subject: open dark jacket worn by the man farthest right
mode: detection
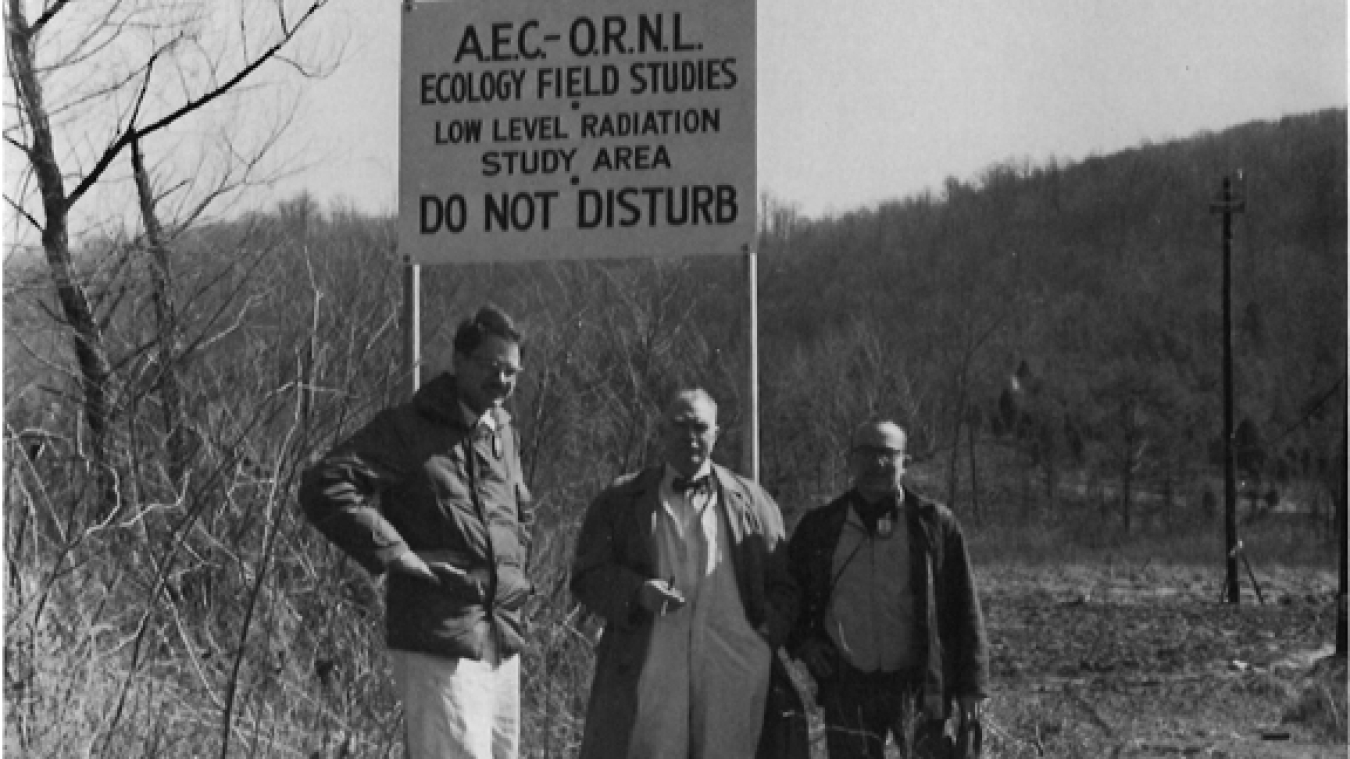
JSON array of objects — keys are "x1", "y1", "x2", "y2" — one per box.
[{"x1": 788, "y1": 489, "x2": 990, "y2": 718}]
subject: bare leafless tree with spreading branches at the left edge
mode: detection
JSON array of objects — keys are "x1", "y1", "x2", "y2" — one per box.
[{"x1": 5, "y1": 0, "x2": 328, "y2": 515}]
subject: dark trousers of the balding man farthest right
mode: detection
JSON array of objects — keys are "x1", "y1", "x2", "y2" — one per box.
[{"x1": 819, "y1": 664, "x2": 942, "y2": 759}]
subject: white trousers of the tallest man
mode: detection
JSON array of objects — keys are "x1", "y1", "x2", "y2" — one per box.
[{"x1": 389, "y1": 642, "x2": 520, "y2": 759}]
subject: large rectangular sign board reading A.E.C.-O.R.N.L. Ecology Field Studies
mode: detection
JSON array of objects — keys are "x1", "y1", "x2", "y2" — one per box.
[{"x1": 398, "y1": 0, "x2": 756, "y2": 263}]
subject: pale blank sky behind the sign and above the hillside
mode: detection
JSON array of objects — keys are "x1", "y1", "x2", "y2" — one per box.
[{"x1": 263, "y1": 0, "x2": 1347, "y2": 216}]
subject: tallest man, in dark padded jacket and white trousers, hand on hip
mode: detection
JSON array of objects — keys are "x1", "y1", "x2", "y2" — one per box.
[{"x1": 300, "y1": 307, "x2": 531, "y2": 759}]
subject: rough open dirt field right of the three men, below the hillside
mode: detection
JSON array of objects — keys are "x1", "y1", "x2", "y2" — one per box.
[{"x1": 793, "y1": 566, "x2": 1346, "y2": 759}]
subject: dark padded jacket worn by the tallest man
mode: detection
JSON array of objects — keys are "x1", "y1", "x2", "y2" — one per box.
[{"x1": 300, "y1": 374, "x2": 532, "y2": 659}]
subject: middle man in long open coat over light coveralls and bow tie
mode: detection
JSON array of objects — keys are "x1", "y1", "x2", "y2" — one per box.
[{"x1": 571, "y1": 390, "x2": 797, "y2": 759}]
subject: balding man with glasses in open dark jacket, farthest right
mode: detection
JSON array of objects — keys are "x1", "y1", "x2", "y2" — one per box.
[{"x1": 788, "y1": 421, "x2": 988, "y2": 759}]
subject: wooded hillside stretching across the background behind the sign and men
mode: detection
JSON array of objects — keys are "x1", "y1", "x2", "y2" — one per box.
[{"x1": 7, "y1": 109, "x2": 1347, "y2": 526}]
